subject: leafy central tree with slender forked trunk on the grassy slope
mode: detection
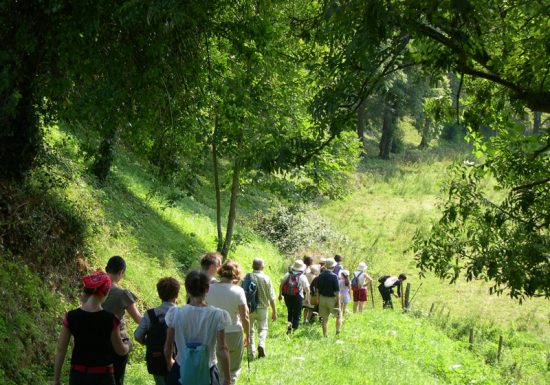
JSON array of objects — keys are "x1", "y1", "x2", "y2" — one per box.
[{"x1": 209, "y1": 2, "x2": 362, "y2": 257}]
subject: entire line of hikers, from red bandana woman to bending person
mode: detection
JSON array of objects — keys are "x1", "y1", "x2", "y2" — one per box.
[{"x1": 54, "y1": 253, "x2": 406, "y2": 385}]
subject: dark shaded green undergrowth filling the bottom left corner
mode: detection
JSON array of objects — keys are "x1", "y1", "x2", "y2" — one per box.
[{"x1": 0, "y1": 254, "x2": 67, "y2": 385}]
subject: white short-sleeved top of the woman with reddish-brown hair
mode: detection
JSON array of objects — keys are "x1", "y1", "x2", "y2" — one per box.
[{"x1": 206, "y1": 282, "x2": 246, "y2": 332}]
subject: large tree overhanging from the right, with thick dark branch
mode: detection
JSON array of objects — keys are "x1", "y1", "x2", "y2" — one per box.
[{"x1": 312, "y1": 0, "x2": 550, "y2": 298}]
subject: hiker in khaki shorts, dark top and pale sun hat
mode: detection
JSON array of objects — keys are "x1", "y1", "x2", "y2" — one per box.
[{"x1": 316, "y1": 258, "x2": 342, "y2": 337}]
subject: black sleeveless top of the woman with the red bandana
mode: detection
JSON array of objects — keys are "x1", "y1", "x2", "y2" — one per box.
[{"x1": 65, "y1": 308, "x2": 120, "y2": 366}]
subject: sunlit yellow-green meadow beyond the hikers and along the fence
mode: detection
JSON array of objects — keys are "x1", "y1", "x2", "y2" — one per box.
[{"x1": 318, "y1": 152, "x2": 550, "y2": 339}]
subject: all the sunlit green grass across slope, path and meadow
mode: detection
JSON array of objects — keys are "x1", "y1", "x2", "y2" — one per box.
[{"x1": 0, "y1": 124, "x2": 550, "y2": 385}]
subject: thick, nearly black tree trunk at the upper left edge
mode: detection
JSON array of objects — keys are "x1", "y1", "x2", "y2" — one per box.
[{"x1": 0, "y1": 1, "x2": 46, "y2": 182}]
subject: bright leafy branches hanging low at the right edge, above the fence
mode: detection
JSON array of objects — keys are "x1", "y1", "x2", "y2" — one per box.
[{"x1": 414, "y1": 121, "x2": 550, "y2": 300}]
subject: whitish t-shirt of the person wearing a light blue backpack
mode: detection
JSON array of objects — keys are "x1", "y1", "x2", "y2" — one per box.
[{"x1": 164, "y1": 305, "x2": 231, "y2": 367}]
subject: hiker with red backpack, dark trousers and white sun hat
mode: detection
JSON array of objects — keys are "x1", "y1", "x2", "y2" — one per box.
[{"x1": 279, "y1": 259, "x2": 310, "y2": 334}]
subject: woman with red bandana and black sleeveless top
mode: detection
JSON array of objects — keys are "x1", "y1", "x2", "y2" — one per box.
[{"x1": 53, "y1": 271, "x2": 132, "y2": 385}]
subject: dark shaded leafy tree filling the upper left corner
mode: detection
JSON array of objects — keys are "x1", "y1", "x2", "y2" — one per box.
[{"x1": 0, "y1": 1, "x2": 211, "y2": 181}]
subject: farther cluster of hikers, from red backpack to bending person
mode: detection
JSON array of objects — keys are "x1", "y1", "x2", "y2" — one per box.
[{"x1": 279, "y1": 254, "x2": 407, "y2": 337}]
